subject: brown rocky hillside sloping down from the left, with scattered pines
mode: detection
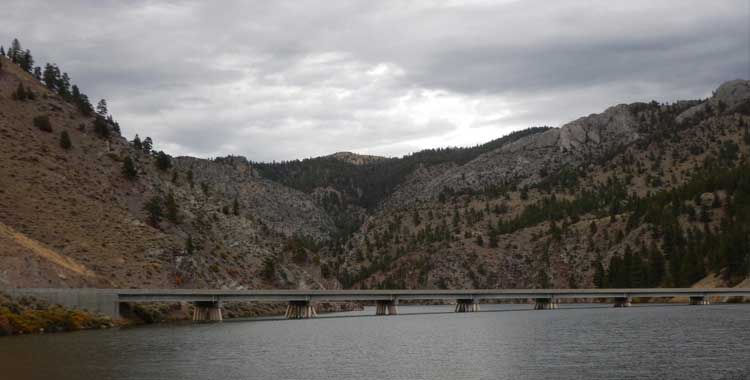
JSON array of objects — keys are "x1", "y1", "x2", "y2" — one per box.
[{"x1": 0, "y1": 53, "x2": 336, "y2": 288}]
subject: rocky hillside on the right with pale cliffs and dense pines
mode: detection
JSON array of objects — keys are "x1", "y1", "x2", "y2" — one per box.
[{"x1": 340, "y1": 81, "x2": 750, "y2": 288}]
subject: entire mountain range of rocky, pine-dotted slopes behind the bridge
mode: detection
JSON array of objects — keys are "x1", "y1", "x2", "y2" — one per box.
[{"x1": 0, "y1": 51, "x2": 750, "y2": 294}]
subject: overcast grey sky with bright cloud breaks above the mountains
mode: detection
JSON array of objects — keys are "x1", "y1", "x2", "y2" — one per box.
[{"x1": 0, "y1": 0, "x2": 750, "y2": 161}]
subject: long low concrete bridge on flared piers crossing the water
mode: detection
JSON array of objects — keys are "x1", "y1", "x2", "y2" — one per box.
[{"x1": 0, "y1": 288, "x2": 750, "y2": 321}]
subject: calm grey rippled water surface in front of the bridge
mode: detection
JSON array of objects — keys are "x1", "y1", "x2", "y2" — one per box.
[{"x1": 0, "y1": 305, "x2": 750, "y2": 380}]
